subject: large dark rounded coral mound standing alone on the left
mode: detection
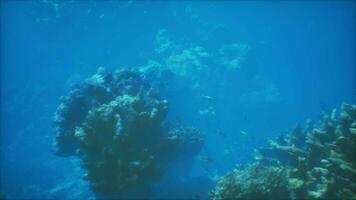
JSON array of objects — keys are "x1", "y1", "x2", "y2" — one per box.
[{"x1": 54, "y1": 68, "x2": 203, "y2": 197}]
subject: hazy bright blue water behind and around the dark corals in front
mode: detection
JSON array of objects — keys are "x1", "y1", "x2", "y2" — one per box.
[{"x1": 0, "y1": 0, "x2": 356, "y2": 199}]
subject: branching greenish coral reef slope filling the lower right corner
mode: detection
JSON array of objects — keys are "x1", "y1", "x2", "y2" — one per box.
[{"x1": 210, "y1": 104, "x2": 356, "y2": 199}]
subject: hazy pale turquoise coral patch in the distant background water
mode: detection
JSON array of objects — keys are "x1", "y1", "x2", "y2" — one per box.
[{"x1": 139, "y1": 29, "x2": 251, "y2": 84}]
